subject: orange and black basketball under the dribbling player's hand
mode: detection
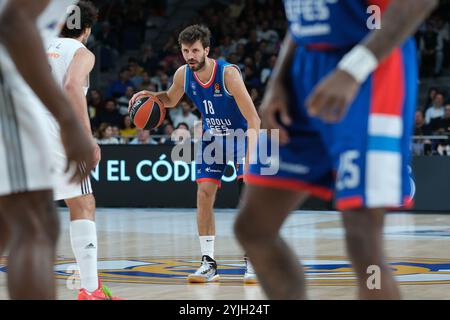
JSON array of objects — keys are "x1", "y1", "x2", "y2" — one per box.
[{"x1": 130, "y1": 96, "x2": 166, "y2": 130}]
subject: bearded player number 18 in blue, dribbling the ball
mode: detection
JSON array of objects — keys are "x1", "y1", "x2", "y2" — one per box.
[{"x1": 130, "y1": 25, "x2": 260, "y2": 283}]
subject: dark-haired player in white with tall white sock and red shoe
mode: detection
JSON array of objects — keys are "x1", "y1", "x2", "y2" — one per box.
[{"x1": 46, "y1": 1, "x2": 120, "y2": 300}]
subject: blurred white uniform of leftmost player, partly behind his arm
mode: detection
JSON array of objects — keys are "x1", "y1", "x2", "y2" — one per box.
[{"x1": 0, "y1": 0, "x2": 78, "y2": 196}]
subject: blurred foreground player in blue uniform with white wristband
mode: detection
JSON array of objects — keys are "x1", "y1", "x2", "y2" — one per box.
[{"x1": 235, "y1": 0, "x2": 437, "y2": 299}]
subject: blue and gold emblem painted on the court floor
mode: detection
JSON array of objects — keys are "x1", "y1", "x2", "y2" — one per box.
[{"x1": 39, "y1": 256, "x2": 450, "y2": 286}]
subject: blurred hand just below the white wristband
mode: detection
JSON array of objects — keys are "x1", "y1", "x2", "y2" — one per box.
[{"x1": 306, "y1": 69, "x2": 360, "y2": 122}]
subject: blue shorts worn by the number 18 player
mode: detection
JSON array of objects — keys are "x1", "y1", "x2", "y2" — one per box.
[{"x1": 195, "y1": 136, "x2": 246, "y2": 187}]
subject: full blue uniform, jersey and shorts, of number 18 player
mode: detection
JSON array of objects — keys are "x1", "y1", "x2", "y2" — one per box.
[{"x1": 184, "y1": 60, "x2": 247, "y2": 185}]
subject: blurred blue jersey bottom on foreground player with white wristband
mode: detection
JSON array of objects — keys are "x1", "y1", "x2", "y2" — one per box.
[{"x1": 284, "y1": 0, "x2": 390, "y2": 49}]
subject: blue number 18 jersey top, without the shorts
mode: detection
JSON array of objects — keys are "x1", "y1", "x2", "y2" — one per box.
[{"x1": 184, "y1": 60, "x2": 247, "y2": 136}]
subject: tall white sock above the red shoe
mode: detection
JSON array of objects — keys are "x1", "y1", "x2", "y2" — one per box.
[{"x1": 70, "y1": 220, "x2": 98, "y2": 292}]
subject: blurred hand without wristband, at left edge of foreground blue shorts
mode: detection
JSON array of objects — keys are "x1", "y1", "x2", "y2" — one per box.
[{"x1": 260, "y1": 83, "x2": 292, "y2": 144}]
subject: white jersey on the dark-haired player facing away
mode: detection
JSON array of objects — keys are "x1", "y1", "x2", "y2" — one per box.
[{"x1": 47, "y1": 38, "x2": 89, "y2": 95}]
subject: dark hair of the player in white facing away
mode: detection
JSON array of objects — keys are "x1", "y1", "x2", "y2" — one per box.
[{"x1": 61, "y1": 1, "x2": 98, "y2": 38}]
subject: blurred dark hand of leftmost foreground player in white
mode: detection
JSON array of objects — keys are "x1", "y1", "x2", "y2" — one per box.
[{"x1": 60, "y1": 121, "x2": 97, "y2": 183}]
